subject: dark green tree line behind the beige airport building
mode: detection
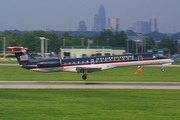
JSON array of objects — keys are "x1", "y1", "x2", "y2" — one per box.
[{"x1": 0, "y1": 30, "x2": 178, "y2": 54}]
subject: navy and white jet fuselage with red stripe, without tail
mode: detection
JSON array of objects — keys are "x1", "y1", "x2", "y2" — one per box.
[{"x1": 22, "y1": 53, "x2": 173, "y2": 72}]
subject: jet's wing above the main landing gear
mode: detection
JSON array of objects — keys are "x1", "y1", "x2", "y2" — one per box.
[{"x1": 76, "y1": 67, "x2": 102, "y2": 73}]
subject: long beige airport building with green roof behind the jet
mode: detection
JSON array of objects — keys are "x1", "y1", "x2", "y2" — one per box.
[{"x1": 60, "y1": 46, "x2": 125, "y2": 58}]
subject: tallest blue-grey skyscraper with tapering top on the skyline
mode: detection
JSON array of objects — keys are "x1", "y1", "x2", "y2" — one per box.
[{"x1": 93, "y1": 5, "x2": 106, "y2": 32}]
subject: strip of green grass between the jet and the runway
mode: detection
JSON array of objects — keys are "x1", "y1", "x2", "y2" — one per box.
[{"x1": 0, "y1": 66, "x2": 180, "y2": 82}]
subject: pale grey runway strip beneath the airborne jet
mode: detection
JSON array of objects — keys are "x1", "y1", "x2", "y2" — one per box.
[{"x1": 0, "y1": 81, "x2": 180, "y2": 89}]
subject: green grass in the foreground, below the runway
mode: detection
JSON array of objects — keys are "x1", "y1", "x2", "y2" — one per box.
[{"x1": 0, "y1": 89, "x2": 180, "y2": 120}]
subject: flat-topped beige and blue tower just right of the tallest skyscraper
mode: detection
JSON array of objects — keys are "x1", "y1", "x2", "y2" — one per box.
[{"x1": 108, "y1": 18, "x2": 119, "y2": 32}]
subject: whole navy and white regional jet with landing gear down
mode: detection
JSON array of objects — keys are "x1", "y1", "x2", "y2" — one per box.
[{"x1": 8, "y1": 46, "x2": 174, "y2": 80}]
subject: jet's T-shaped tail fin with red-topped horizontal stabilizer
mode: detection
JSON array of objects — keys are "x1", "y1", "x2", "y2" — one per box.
[{"x1": 7, "y1": 46, "x2": 37, "y2": 65}]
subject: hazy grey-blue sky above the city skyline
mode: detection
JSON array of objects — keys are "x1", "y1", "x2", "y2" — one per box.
[{"x1": 0, "y1": 0, "x2": 180, "y2": 33}]
